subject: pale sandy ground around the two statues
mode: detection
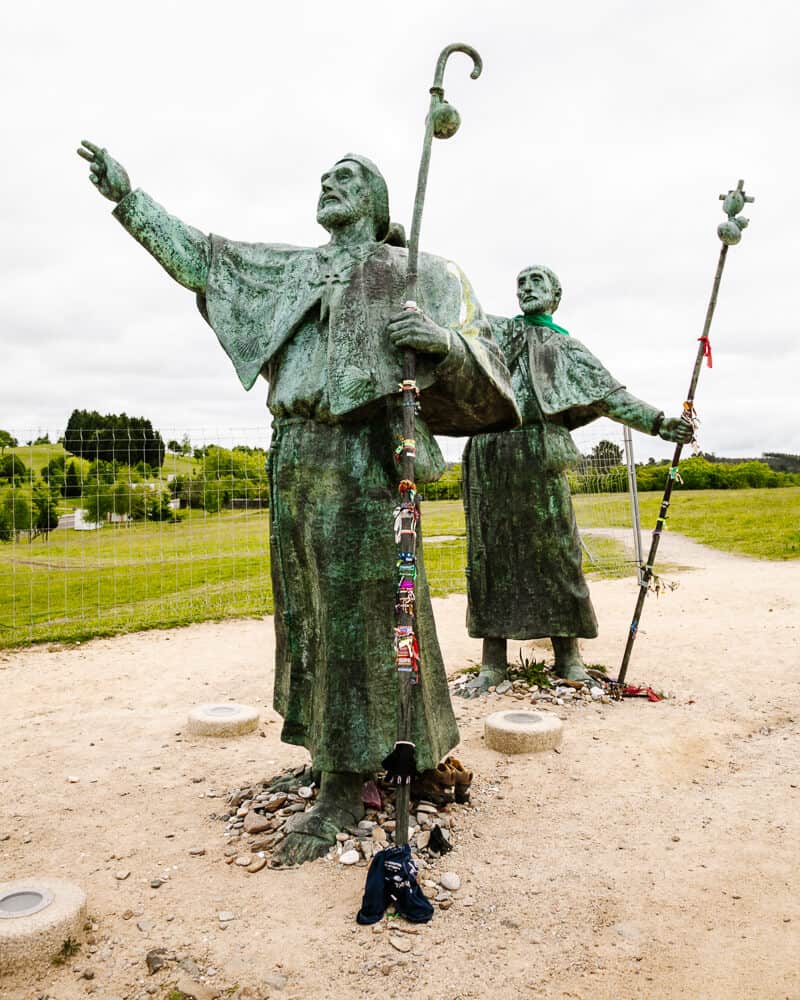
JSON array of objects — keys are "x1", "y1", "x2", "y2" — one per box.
[{"x1": 0, "y1": 535, "x2": 800, "y2": 1000}]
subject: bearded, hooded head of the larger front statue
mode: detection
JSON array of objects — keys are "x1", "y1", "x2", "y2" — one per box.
[{"x1": 317, "y1": 153, "x2": 389, "y2": 240}]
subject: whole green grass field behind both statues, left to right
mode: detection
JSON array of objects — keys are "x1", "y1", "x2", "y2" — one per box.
[{"x1": 0, "y1": 486, "x2": 800, "y2": 647}]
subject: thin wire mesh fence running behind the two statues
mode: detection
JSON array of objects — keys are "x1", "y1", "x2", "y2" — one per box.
[{"x1": 0, "y1": 421, "x2": 635, "y2": 647}]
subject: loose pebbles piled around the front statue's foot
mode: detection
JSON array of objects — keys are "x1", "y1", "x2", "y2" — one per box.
[{"x1": 212, "y1": 767, "x2": 462, "y2": 874}]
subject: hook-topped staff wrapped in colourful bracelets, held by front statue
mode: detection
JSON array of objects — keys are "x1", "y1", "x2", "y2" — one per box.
[{"x1": 384, "y1": 43, "x2": 483, "y2": 847}]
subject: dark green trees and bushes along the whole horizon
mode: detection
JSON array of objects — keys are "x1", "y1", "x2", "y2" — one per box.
[{"x1": 0, "y1": 410, "x2": 800, "y2": 541}]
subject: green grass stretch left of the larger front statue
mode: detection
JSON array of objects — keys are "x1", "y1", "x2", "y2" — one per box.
[{"x1": 0, "y1": 511, "x2": 272, "y2": 646}]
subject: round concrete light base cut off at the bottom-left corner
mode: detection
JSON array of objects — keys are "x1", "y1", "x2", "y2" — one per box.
[{"x1": 0, "y1": 878, "x2": 86, "y2": 973}]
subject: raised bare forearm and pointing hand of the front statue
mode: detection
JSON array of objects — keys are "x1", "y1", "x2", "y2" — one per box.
[{"x1": 78, "y1": 139, "x2": 211, "y2": 292}]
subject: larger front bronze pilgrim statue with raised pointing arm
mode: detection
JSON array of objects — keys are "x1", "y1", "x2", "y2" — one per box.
[{"x1": 78, "y1": 142, "x2": 518, "y2": 863}]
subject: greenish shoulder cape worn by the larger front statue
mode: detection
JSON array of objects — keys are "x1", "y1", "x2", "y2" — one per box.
[{"x1": 198, "y1": 236, "x2": 519, "y2": 434}]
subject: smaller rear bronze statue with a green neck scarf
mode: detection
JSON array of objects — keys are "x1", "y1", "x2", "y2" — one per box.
[{"x1": 463, "y1": 266, "x2": 692, "y2": 695}]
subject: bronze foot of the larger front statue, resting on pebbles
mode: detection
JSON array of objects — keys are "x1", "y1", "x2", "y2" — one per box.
[{"x1": 272, "y1": 773, "x2": 364, "y2": 867}]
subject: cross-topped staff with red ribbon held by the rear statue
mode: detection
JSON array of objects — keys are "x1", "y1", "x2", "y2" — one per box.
[{"x1": 617, "y1": 180, "x2": 755, "y2": 690}]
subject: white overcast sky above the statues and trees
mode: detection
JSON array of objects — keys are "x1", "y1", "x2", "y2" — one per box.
[{"x1": 0, "y1": 0, "x2": 800, "y2": 457}]
